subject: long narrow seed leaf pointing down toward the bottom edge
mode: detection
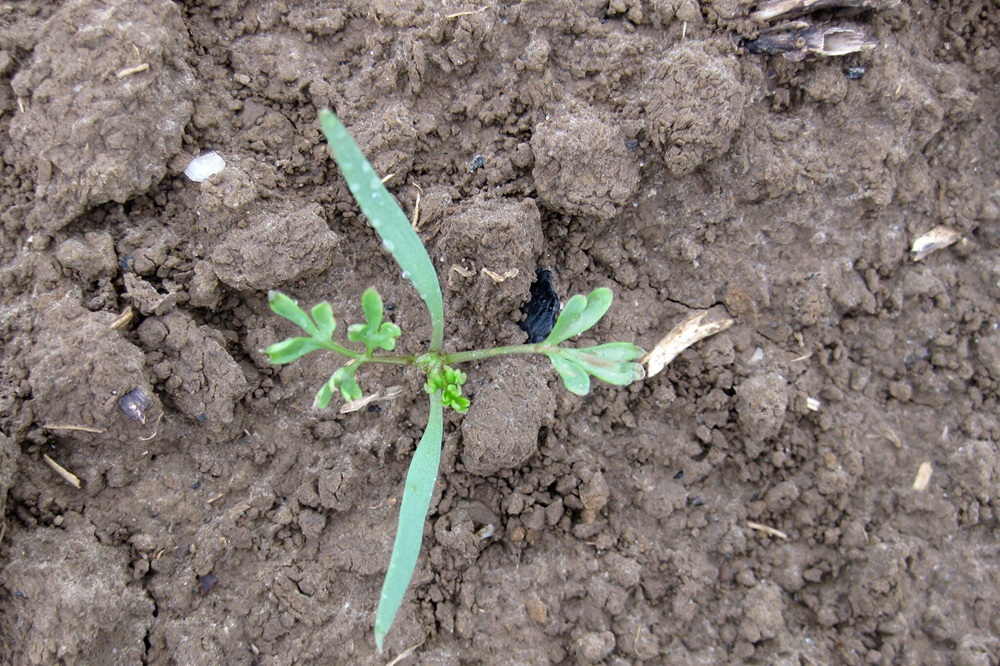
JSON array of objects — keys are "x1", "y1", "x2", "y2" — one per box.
[{"x1": 375, "y1": 393, "x2": 444, "y2": 652}]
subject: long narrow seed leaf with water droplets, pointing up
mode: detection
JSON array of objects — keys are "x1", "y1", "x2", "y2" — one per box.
[{"x1": 319, "y1": 109, "x2": 444, "y2": 351}]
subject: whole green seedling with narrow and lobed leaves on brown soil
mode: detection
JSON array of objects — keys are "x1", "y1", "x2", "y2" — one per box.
[{"x1": 264, "y1": 109, "x2": 645, "y2": 651}]
